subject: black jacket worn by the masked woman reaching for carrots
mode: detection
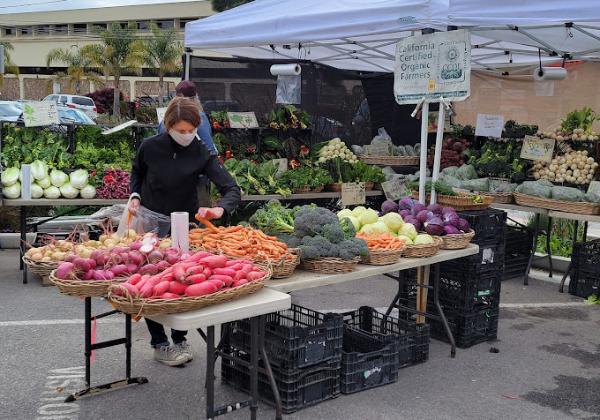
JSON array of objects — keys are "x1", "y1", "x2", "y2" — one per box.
[{"x1": 130, "y1": 133, "x2": 241, "y2": 220}]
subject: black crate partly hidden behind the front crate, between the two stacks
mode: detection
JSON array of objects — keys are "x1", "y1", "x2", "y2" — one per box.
[{"x1": 343, "y1": 306, "x2": 429, "y2": 368}]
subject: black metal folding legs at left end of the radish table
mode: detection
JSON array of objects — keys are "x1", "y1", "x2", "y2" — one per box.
[{"x1": 65, "y1": 297, "x2": 148, "y2": 402}]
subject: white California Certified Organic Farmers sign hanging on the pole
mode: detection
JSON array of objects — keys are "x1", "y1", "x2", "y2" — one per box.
[{"x1": 394, "y1": 30, "x2": 471, "y2": 105}]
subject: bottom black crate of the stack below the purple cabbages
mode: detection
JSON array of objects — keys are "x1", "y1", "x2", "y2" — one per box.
[{"x1": 427, "y1": 303, "x2": 500, "y2": 349}]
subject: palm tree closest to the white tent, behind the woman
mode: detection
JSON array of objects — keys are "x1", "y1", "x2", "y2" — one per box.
[{"x1": 142, "y1": 23, "x2": 183, "y2": 107}]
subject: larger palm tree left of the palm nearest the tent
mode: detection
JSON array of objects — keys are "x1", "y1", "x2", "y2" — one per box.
[{"x1": 81, "y1": 22, "x2": 144, "y2": 117}]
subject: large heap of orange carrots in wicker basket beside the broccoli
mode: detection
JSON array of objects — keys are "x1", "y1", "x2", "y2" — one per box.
[{"x1": 189, "y1": 219, "x2": 301, "y2": 279}]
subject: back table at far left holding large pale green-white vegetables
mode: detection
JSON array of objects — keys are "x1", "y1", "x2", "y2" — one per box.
[{"x1": 2, "y1": 198, "x2": 127, "y2": 284}]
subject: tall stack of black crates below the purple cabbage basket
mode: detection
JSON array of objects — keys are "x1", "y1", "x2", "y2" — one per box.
[{"x1": 399, "y1": 209, "x2": 506, "y2": 348}]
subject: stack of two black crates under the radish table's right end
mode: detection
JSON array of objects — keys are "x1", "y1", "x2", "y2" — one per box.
[{"x1": 221, "y1": 305, "x2": 344, "y2": 414}]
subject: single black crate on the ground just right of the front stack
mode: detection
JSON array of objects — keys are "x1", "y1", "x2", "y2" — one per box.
[{"x1": 340, "y1": 327, "x2": 399, "y2": 394}]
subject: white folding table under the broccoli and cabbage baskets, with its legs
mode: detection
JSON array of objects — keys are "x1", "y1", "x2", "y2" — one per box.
[{"x1": 265, "y1": 244, "x2": 479, "y2": 357}]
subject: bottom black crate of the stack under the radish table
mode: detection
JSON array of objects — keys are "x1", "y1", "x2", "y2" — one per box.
[{"x1": 221, "y1": 346, "x2": 341, "y2": 414}]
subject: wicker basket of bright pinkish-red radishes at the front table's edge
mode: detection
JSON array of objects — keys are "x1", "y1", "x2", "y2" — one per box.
[{"x1": 108, "y1": 251, "x2": 272, "y2": 316}]
